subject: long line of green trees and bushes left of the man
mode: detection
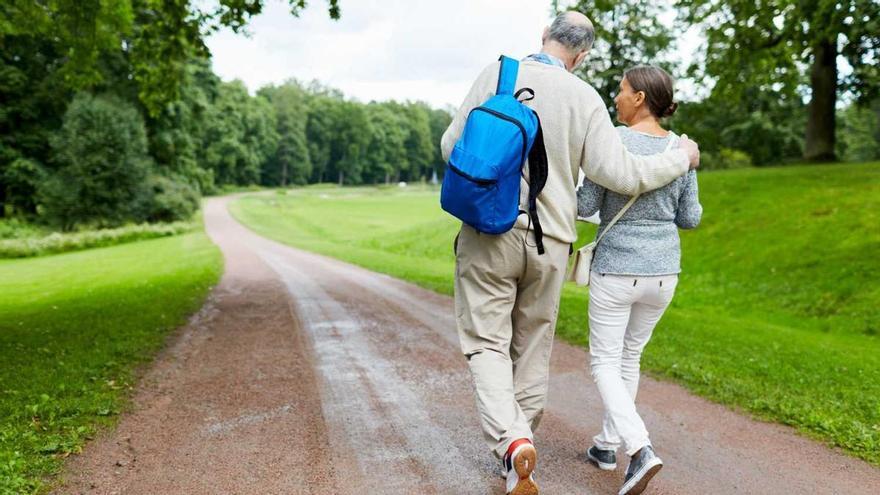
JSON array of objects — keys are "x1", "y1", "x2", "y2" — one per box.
[{"x1": 0, "y1": 54, "x2": 451, "y2": 230}]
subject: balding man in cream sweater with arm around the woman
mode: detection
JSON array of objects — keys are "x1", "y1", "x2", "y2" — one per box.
[{"x1": 441, "y1": 8, "x2": 699, "y2": 495}]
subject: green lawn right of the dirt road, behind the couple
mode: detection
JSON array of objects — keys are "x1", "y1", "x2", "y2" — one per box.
[{"x1": 231, "y1": 163, "x2": 880, "y2": 465}]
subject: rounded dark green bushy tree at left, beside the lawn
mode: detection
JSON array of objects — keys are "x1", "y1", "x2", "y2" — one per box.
[{"x1": 39, "y1": 93, "x2": 151, "y2": 230}]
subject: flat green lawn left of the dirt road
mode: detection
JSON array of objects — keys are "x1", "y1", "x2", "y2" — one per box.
[{"x1": 0, "y1": 232, "x2": 222, "y2": 494}]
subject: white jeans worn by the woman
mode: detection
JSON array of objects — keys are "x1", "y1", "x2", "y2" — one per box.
[{"x1": 589, "y1": 272, "x2": 678, "y2": 456}]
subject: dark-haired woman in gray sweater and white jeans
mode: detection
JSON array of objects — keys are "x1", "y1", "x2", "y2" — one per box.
[{"x1": 578, "y1": 66, "x2": 702, "y2": 495}]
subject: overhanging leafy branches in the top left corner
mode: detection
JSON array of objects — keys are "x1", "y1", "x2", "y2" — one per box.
[{"x1": 0, "y1": 0, "x2": 340, "y2": 116}]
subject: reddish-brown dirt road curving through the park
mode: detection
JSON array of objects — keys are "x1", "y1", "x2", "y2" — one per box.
[{"x1": 58, "y1": 198, "x2": 880, "y2": 495}]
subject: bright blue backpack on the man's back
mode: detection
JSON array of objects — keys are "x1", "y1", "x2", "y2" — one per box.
[{"x1": 440, "y1": 55, "x2": 547, "y2": 254}]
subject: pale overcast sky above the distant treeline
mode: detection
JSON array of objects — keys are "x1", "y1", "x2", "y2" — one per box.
[{"x1": 208, "y1": 0, "x2": 700, "y2": 107}]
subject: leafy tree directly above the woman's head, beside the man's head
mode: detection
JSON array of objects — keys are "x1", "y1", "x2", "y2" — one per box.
[{"x1": 554, "y1": 0, "x2": 674, "y2": 118}]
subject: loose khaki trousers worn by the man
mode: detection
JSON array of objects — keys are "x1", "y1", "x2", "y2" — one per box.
[{"x1": 455, "y1": 225, "x2": 569, "y2": 458}]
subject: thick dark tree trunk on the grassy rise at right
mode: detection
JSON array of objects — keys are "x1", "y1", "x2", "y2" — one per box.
[{"x1": 804, "y1": 40, "x2": 837, "y2": 162}]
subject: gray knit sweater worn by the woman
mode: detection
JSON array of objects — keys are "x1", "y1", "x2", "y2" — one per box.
[{"x1": 577, "y1": 127, "x2": 703, "y2": 275}]
